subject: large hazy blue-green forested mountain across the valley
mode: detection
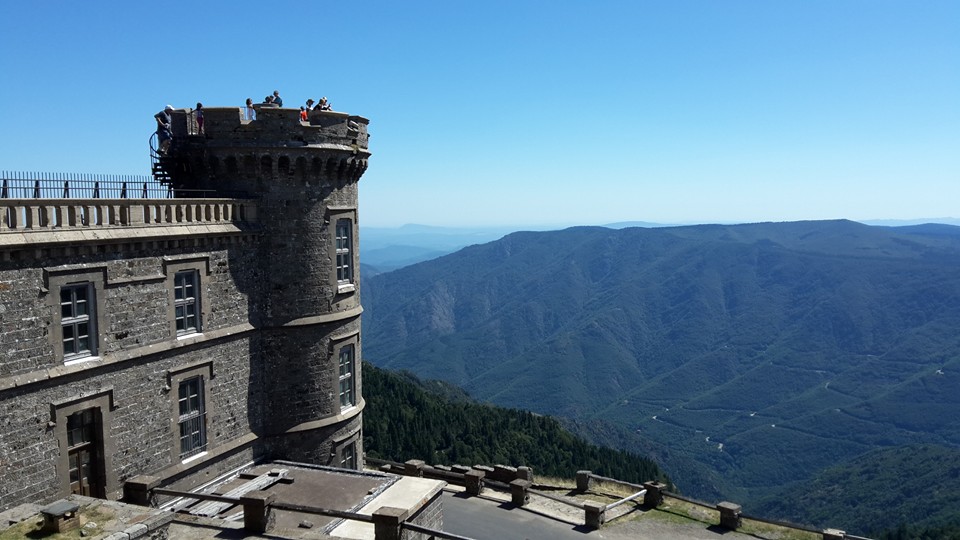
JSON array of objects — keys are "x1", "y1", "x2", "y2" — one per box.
[{"x1": 363, "y1": 221, "x2": 960, "y2": 520}]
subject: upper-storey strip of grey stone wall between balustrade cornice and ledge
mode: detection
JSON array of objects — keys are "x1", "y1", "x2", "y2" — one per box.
[{"x1": 0, "y1": 239, "x2": 261, "y2": 380}]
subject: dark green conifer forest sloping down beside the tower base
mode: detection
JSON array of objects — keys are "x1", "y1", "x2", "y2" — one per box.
[{"x1": 363, "y1": 364, "x2": 672, "y2": 486}]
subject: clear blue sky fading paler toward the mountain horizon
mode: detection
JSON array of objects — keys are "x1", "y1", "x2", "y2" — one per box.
[{"x1": 0, "y1": 0, "x2": 960, "y2": 226}]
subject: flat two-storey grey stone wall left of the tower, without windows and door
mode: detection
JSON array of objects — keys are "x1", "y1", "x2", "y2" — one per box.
[{"x1": 0, "y1": 236, "x2": 264, "y2": 508}]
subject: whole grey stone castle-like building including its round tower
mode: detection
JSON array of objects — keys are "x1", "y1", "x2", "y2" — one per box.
[{"x1": 0, "y1": 103, "x2": 370, "y2": 510}]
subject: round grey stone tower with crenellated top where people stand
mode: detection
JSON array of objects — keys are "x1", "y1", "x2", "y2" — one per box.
[{"x1": 159, "y1": 107, "x2": 370, "y2": 468}]
